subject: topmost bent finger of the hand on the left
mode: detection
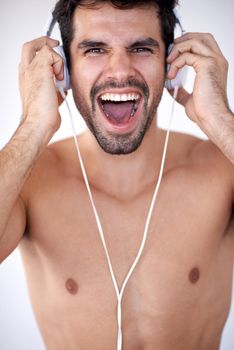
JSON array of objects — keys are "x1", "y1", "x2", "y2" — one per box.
[{"x1": 20, "y1": 36, "x2": 59, "y2": 69}]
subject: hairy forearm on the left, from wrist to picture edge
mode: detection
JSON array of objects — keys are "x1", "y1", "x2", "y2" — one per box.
[{"x1": 0, "y1": 122, "x2": 50, "y2": 238}]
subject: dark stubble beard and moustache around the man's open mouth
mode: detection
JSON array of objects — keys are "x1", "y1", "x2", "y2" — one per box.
[{"x1": 73, "y1": 81, "x2": 163, "y2": 155}]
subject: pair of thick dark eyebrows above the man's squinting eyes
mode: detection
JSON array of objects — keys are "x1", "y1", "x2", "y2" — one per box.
[{"x1": 78, "y1": 38, "x2": 160, "y2": 50}]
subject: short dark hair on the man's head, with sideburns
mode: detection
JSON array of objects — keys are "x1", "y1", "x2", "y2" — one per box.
[{"x1": 53, "y1": 0, "x2": 177, "y2": 70}]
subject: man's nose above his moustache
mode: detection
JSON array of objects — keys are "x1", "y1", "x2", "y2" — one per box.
[{"x1": 106, "y1": 50, "x2": 136, "y2": 82}]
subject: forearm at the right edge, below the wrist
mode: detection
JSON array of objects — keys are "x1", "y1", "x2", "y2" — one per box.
[{"x1": 202, "y1": 111, "x2": 234, "y2": 165}]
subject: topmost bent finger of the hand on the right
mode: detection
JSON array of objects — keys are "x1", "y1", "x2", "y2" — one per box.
[{"x1": 174, "y1": 33, "x2": 222, "y2": 55}]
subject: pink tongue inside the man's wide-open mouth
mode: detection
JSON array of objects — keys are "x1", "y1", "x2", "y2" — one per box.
[{"x1": 103, "y1": 102, "x2": 134, "y2": 124}]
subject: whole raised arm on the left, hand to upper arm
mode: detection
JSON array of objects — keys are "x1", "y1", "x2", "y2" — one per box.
[{"x1": 0, "y1": 37, "x2": 63, "y2": 262}]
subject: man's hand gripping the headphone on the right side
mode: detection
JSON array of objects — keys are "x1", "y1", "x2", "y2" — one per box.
[{"x1": 167, "y1": 33, "x2": 229, "y2": 124}]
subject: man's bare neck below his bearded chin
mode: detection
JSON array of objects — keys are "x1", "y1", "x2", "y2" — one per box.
[{"x1": 82, "y1": 120, "x2": 165, "y2": 198}]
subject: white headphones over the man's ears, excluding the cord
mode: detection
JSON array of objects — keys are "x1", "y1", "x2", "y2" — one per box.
[{"x1": 44, "y1": 9, "x2": 188, "y2": 91}]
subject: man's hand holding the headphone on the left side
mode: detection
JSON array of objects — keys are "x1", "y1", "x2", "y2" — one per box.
[{"x1": 19, "y1": 37, "x2": 63, "y2": 134}]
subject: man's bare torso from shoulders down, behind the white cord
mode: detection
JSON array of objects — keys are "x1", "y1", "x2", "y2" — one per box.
[{"x1": 18, "y1": 129, "x2": 234, "y2": 350}]
